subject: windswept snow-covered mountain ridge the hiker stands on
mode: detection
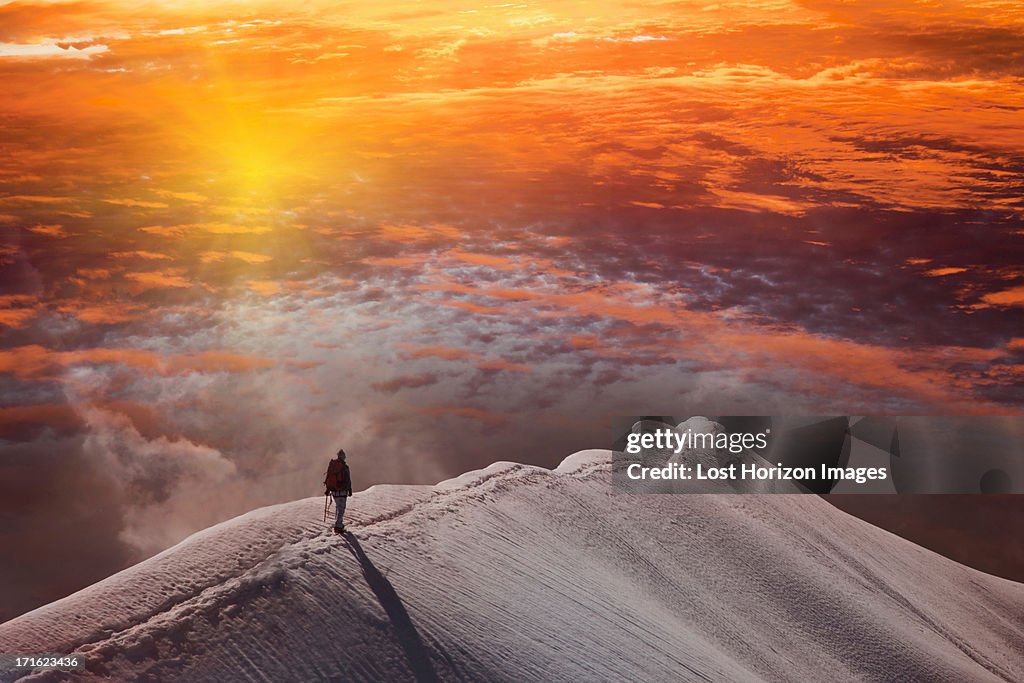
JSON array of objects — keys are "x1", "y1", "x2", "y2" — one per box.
[{"x1": 0, "y1": 451, "x2": 1024, "y2": 681}]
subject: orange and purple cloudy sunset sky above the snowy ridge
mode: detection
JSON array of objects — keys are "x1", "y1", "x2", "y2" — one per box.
[{"x1": 0, "y1": 0, "x2": 1024, "y2": 617}]
